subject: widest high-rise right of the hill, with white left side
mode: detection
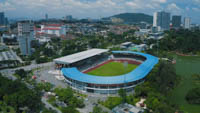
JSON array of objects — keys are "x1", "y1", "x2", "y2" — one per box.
[{"x1": 153, "y1": 11, "x2": 170, "y2": 31}]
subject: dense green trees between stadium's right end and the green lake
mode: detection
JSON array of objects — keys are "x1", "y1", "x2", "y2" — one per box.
[{"x1": 135, "y1": 61, "x2": 177, "y2": 113}]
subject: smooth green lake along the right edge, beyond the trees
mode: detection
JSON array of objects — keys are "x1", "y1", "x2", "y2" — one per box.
[{"x1": 169, "y1": 53, "x2": 200, "y2": 113}]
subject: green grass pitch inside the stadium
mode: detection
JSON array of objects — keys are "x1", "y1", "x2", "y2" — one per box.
[{"x1": 87, "y1": 62, "x2": 137, "y2": 76}]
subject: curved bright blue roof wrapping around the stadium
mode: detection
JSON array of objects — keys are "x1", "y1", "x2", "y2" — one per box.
[{"x1": 62, "y1": 51, "x2": 158, "y2": 84}]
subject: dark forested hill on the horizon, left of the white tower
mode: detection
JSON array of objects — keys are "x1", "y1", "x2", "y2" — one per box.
[{"x1": 103, "y1": 13, "x2": 153, "y2": 24}]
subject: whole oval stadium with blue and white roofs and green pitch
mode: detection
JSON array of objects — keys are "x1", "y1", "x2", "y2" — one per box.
[{"x1": 54, "y1": 49, "x2": 158, "y2": 94}]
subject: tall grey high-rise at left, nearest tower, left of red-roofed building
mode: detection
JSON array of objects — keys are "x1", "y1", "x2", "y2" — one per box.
[{"x1": 18, "y1": 21, "x2": 34, "y2": 55}]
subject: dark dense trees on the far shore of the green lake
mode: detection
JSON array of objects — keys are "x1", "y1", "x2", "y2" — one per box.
[{"x1": 159, "y1": 29, "x2": 200, "y2": 54}]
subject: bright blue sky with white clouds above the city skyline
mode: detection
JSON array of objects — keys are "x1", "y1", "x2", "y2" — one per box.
[{"x1": 0, "y1": 0, "x2": 200, "y2": 24}]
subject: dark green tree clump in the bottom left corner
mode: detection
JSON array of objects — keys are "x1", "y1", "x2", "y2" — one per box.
[{"x1": 0, "y1": 74, "x2": 42, "y2": 113}]
